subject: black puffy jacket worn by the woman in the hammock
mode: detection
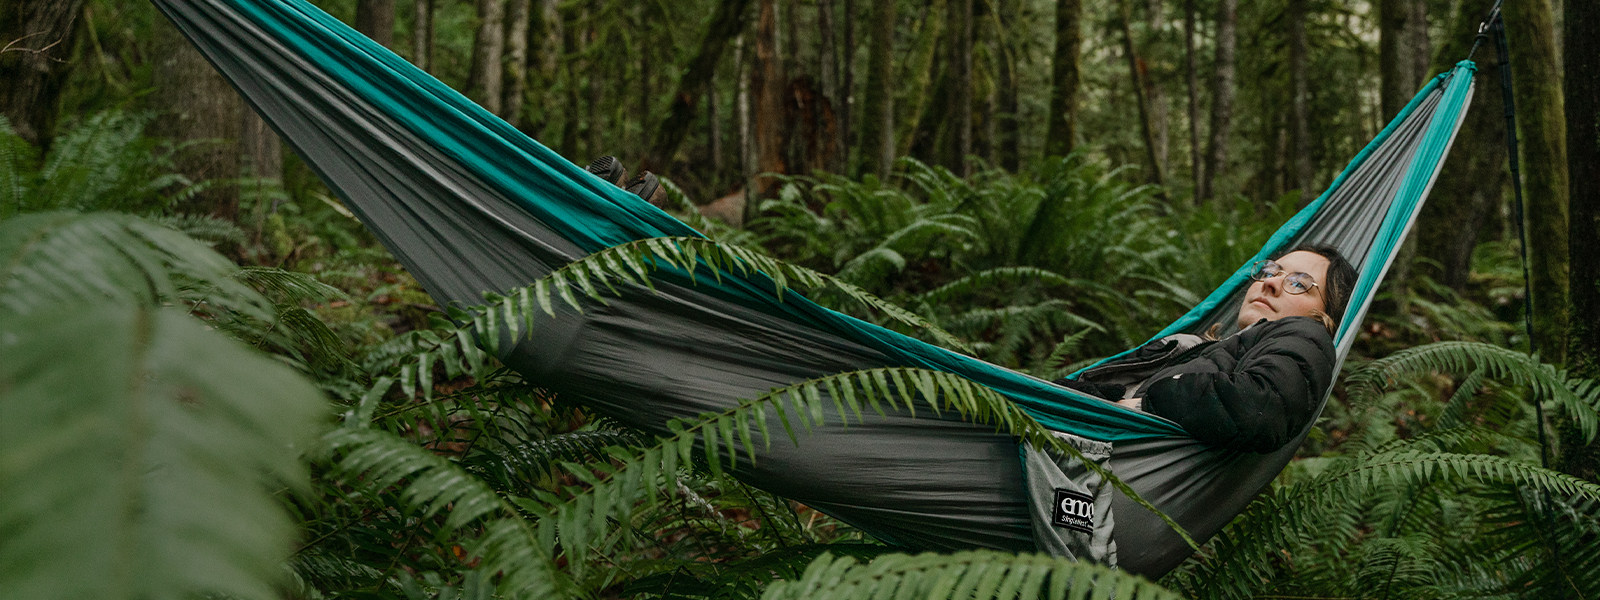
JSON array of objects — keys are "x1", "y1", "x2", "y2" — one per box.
[{"x1": 1062, "y1": 317, "x2": 1334, "y2": 453}]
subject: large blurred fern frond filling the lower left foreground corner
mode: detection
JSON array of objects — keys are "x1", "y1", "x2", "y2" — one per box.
[{"x1": 0, "y1": 302, "x2": 325, "y2": 600}]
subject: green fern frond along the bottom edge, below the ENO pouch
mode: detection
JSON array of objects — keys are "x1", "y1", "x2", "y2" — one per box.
[{"x1": 762, "y1": 550, "x2": 1179, "y2": 600}]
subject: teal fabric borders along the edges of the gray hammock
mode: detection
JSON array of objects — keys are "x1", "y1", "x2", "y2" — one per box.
[{"x1": 216, "y1": 0, "x2": 1474, "y2": 442}]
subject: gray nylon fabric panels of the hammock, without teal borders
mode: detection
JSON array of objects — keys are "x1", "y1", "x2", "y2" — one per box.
[{"x1": 154, "y1": 0, "x2": 1472, "y2": 578}]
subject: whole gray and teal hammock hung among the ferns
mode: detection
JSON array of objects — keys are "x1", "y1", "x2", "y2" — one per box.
[{"x1": 154, "y1": 0, "x2": 1474, "y2": 578}]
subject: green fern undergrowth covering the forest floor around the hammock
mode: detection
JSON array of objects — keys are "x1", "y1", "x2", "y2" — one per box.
[{"x1": 0, "y1": 112, "x2": 1600, "y2": 600}]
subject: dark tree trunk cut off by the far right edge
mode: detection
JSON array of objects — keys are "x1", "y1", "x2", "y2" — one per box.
[{"x1": 1555, "y1": 0, "x2": 1600, "y2": 482}]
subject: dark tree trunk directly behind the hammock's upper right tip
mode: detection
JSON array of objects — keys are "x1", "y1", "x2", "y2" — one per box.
[{"x1": 1411, "y1": 0, "x2": 1506, "y2": 291}]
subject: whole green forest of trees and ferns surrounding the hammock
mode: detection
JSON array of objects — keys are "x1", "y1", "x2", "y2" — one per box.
[{"x1": 0, "y1": 0, "x2": 1600, "y2": 598}]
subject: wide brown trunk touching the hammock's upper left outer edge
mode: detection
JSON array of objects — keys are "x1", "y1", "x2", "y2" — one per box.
[{"x1": 149, "y1": 17, "x2": 245, "y2": 221}]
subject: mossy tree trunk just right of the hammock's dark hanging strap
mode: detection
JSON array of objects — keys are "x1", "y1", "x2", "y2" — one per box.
[{"x1": 1506, "y1": 0, "x2": 1571, "y2": 365}]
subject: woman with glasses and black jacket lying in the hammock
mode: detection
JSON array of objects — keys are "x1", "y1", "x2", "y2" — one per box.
[{"x1": 1056, "y1": 245, "x2": 1357, "y2": 453}]
